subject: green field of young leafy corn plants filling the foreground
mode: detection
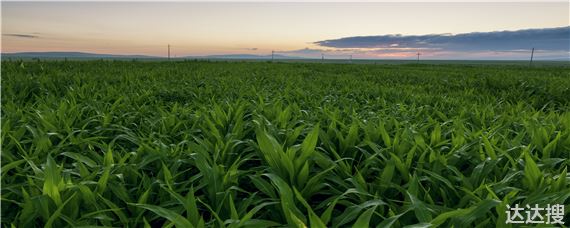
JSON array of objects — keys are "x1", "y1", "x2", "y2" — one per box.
[{"x1": 1, "y1": 60, "x2": 570, "y2": 227}]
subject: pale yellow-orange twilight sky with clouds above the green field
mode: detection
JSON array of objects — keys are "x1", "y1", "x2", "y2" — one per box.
[{"x1": 1, "y1": 1, "x2": 570, "y2": 59}]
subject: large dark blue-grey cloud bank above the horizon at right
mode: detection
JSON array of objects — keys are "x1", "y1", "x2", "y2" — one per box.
[{"x1": 314, "y1": 26, "x2": 570, "y2": 51}]
